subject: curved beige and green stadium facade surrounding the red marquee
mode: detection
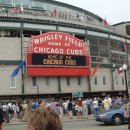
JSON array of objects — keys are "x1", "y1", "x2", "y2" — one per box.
[{"x1": 0, "y1": 0, "x2": 130, "y2": 99}]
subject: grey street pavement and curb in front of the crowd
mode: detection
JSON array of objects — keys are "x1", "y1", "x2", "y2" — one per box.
[{"x1": 3, "y1": 116, "x2": 128, "y2": 130}]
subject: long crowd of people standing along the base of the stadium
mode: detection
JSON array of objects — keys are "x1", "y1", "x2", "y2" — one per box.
[{"x1": 1, "y1": 95, "x2": 126, "y2": 123}]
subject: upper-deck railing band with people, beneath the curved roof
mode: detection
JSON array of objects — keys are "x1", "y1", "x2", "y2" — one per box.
[{"x1": 0, "y1": 6, "x2": 114, "y2": 32}]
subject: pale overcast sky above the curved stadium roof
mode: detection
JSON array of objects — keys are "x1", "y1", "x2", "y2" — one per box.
[{"x1": 56, "y1": 0, "x2": 130, "y2": 25}]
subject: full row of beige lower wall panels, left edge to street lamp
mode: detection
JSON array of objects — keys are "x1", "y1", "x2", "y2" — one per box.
[{"x1": 0, "y1": 65, "x2": 126, "y2": 95}]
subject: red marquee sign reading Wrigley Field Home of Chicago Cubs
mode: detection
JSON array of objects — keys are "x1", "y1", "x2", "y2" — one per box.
[{"x1": 27, "y1": 32, "x2": 90, "y2": 76}]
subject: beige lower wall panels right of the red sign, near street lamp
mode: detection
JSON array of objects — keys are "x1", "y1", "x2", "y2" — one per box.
[{"x1": 91, "y1": 68, "x2": 125, "y2": 92}]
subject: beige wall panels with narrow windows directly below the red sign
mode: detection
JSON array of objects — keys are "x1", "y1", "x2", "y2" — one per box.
[{"x1": 24, "y1": 77, "x2": 89, "y2": 94}]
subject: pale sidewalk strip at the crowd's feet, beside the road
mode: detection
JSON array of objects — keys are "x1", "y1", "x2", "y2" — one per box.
[{"x1": 4, "y1": 115, "x2": 94, "y2": 125}]
